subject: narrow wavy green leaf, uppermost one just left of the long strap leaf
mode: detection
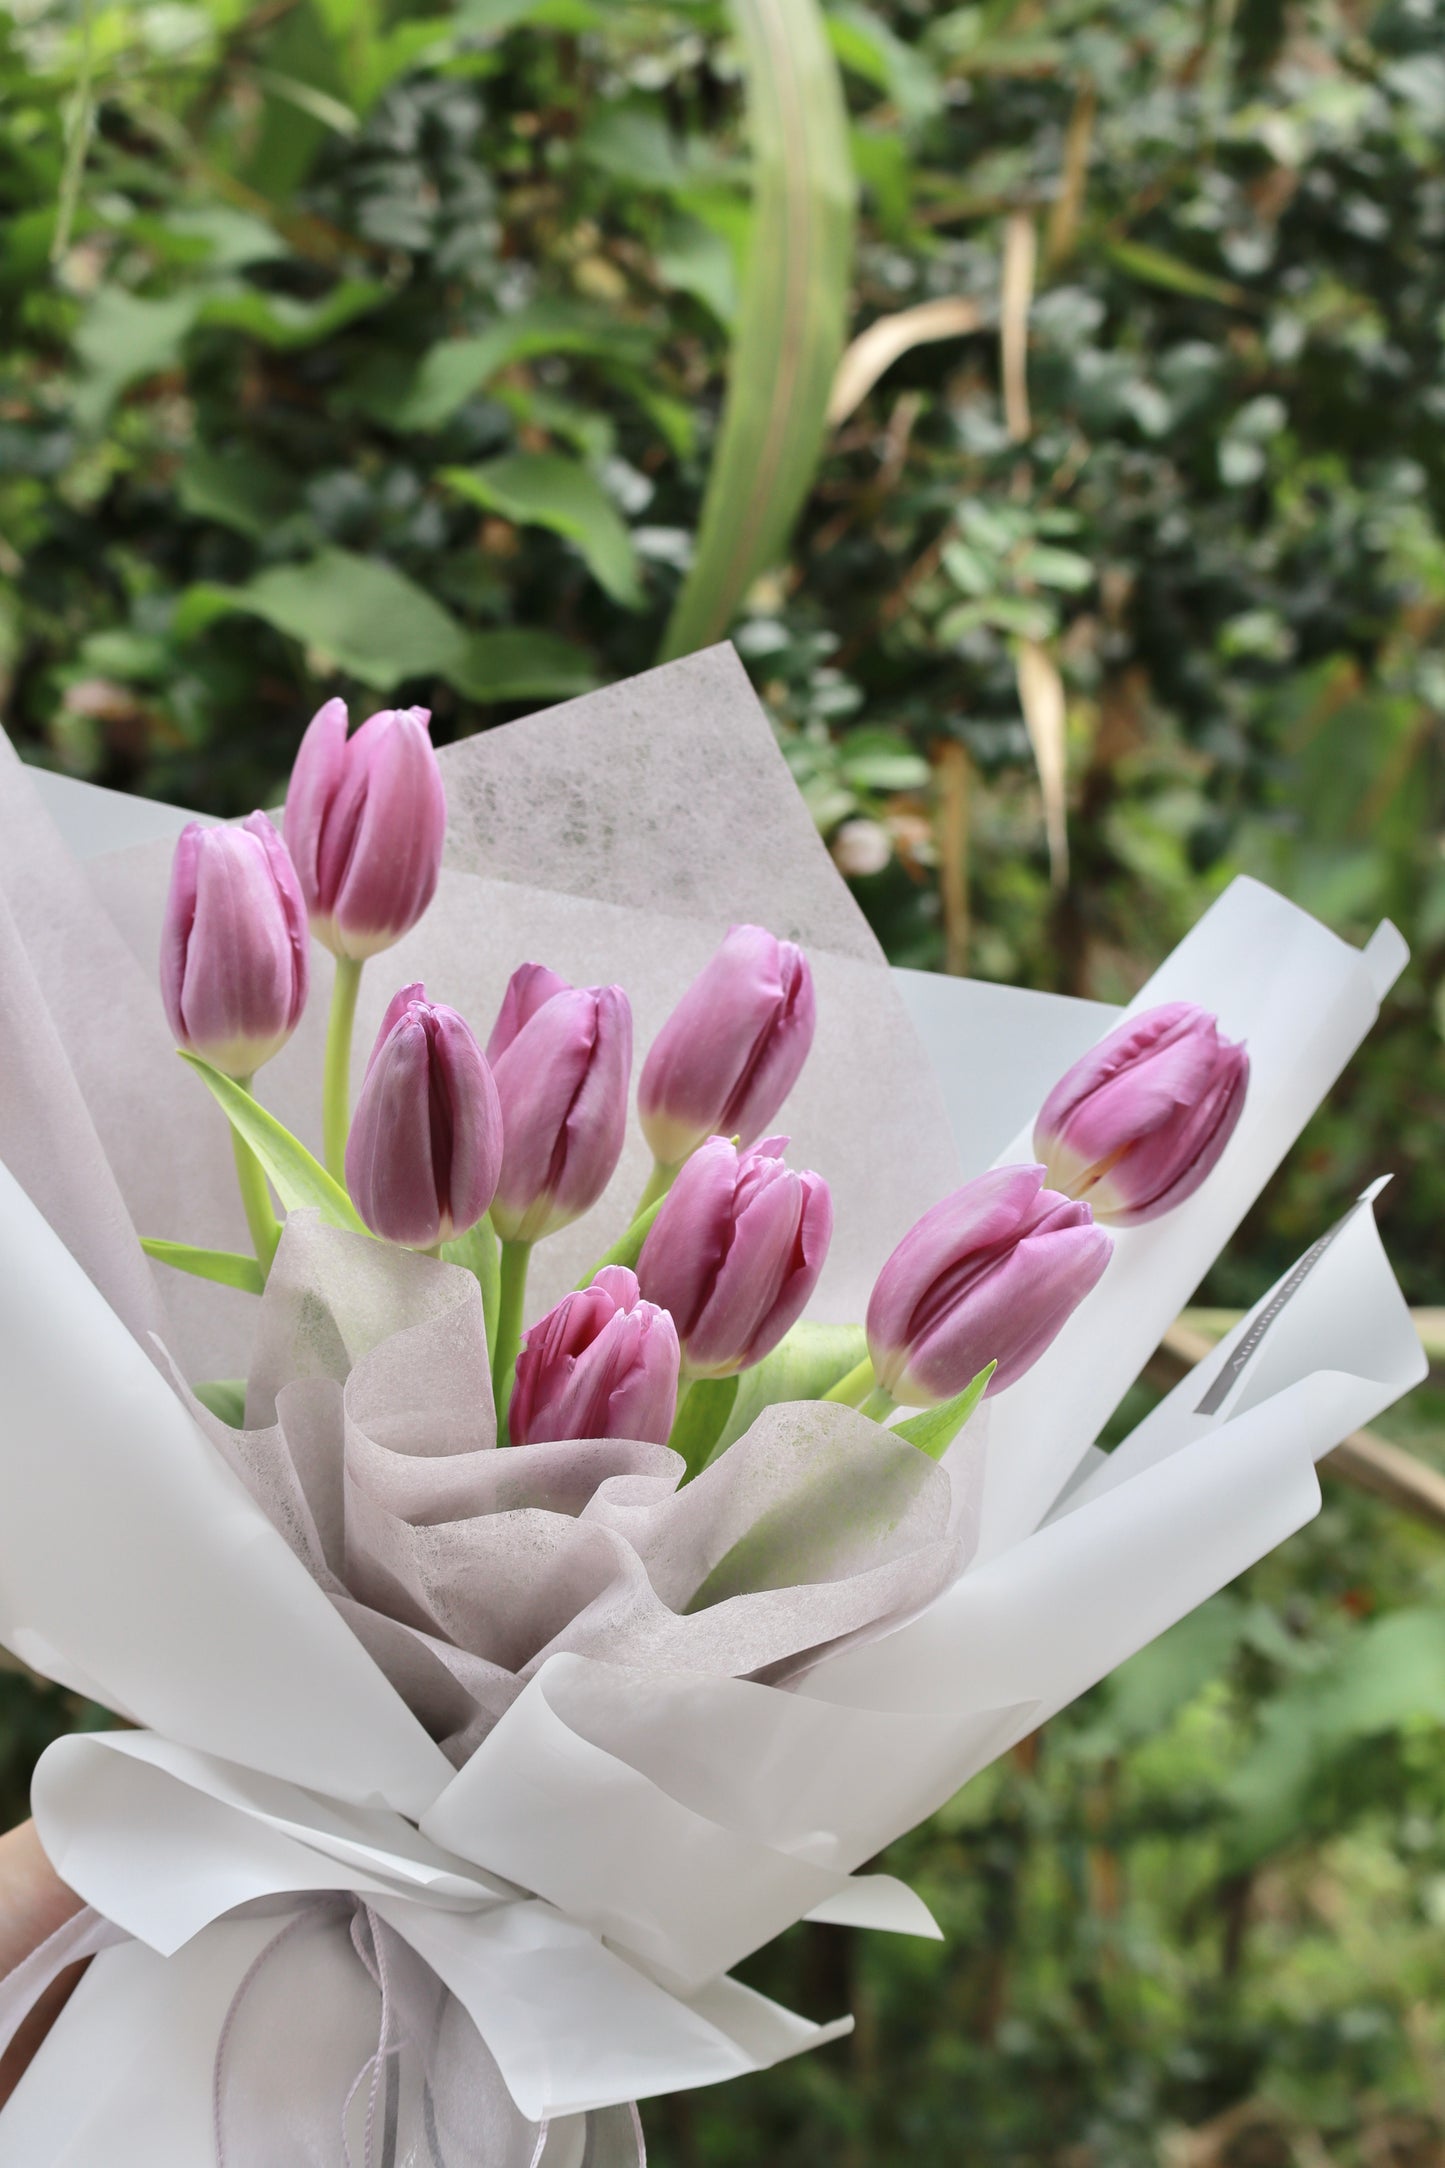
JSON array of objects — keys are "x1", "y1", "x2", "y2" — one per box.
[{"x1": 361, "y1": 299, "x2": 654, "y2": 429}]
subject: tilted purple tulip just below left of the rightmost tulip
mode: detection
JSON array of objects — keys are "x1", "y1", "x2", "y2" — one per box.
[{"x1": 867, "y1": 1166, "x2": 1114, "y2": 1407}]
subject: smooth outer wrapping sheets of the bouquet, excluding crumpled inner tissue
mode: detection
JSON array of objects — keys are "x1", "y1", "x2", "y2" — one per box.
[{"x1": 0, "y1": 653, "x2": 1423, "y2": 2168}]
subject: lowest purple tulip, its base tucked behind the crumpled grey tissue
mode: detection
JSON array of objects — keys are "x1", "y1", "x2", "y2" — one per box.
[{"x1": 511, "y1": 1264, "x2": 678, "y2": 1446}]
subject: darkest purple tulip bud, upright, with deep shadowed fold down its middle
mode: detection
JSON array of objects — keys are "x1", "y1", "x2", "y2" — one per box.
[{"x1": 347, "y1": 984, "x2": 503, "y2": 1249}]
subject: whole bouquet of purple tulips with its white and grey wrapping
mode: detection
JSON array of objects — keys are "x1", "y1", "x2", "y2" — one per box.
[{"x1": 0, "y1": 650, "x2": 1421, "y2": 2168}]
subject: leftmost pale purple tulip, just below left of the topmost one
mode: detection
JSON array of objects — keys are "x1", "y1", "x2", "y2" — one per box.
[{"x1": 160, "y1": 813, "x2": 310, "y2": 1077}]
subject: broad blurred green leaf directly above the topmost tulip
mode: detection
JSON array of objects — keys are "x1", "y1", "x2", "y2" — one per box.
[{"x1": 175, "y1": 549, "x2": 468, "y2": 692}]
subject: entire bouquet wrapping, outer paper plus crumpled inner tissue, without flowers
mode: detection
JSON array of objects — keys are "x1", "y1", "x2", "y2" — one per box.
[{"x1": 0, "y1": 648, "x2": 1423, "y2": 2168}]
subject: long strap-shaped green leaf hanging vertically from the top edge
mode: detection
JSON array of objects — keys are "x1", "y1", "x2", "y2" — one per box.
[{"x1": 663, "y1": 0, "x2": 854, "y2": 659}]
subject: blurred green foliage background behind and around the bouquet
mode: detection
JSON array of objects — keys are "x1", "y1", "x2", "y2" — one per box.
[{"x1": 0, "y1": 0, "x2": 1445, "y2": 2168}]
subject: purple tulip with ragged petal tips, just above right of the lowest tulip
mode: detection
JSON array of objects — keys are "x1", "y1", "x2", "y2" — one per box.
[{"x1": 637, "y1": 1136, "x2": 832, "y2": 1377}]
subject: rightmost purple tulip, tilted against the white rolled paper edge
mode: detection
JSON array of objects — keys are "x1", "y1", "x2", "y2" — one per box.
[{"x1": 1033, "y1": 1002, "x2": 1250, "y2": 1227}]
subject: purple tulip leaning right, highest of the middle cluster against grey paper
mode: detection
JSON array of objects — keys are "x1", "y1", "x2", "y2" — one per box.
[{"x1": 637, "y1": 926, "x2": 817, "y2": 1166}]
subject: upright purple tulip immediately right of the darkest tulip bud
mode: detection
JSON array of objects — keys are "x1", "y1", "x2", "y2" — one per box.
[{"x1": 487, "y1": 963, "x2": 633, "y2": 1242}]
